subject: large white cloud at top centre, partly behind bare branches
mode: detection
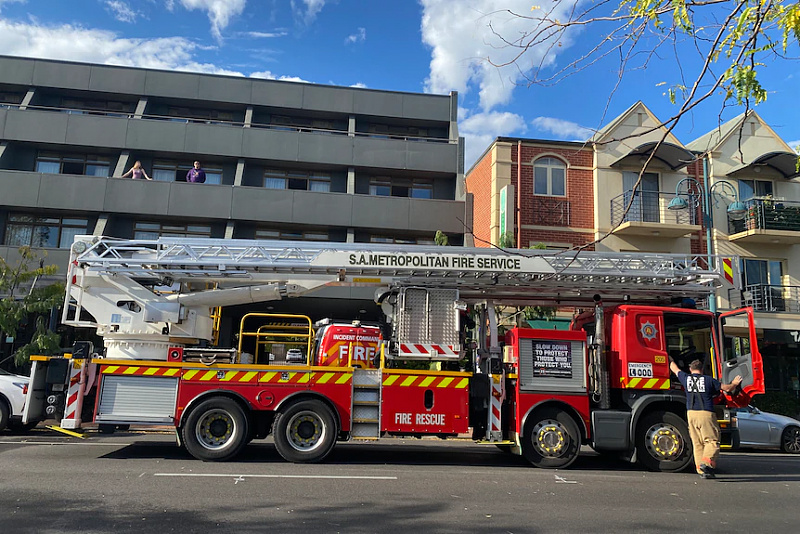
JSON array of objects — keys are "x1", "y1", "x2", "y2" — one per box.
[{"x1": 420, "y1": 0, "x2": 583, "y2": 111}]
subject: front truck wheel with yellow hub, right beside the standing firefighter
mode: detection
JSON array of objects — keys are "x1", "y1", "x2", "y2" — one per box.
[{"x1": 636, "y1": 412, "x2": 692, "y2": 473}]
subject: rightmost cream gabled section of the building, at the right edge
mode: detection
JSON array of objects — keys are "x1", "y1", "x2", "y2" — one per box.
[{"x1": 687, "y1": 111, "x2": 800, "y2": 393}]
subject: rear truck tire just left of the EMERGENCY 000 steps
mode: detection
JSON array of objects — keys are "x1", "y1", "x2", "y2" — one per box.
[{"x1": 272, "y1": 400, "x2": 338, "y2": 463}]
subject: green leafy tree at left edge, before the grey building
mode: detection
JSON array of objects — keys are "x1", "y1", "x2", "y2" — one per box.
[{"x1": 0, "y1": 247, "x2": 64, "y2": 365}]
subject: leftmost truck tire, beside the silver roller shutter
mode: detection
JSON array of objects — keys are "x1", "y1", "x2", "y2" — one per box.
[{"x1": 181, "y1": 397, "x2": 250, "y2": 462}]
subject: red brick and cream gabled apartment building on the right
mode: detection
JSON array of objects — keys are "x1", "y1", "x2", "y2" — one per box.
[{"x1": 466, "y1": 102, "x2": 800, "y2": 398}]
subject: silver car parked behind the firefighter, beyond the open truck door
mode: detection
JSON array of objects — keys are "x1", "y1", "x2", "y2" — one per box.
[{"x1": 735, "y1": 406, "x2": 800, "y2": 454}]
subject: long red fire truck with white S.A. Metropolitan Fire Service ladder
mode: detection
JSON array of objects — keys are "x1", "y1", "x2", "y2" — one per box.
[{"x1": 24, "y1": 236, "x2": 764, "y2": 471}]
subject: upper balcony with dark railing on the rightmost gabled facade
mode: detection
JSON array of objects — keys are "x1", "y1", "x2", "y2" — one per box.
[{"x1": 728, "y1": 198, "x2": 800, "y2": 245}]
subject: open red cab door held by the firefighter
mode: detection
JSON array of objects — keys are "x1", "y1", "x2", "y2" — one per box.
[{"x1": 719, "y1": 308, "x2": 764, "y2": 407}]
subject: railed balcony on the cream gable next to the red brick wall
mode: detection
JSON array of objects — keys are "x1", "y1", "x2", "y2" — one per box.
[{"x1": 611, "y1": 191, "x2": 701, "y2": 238}]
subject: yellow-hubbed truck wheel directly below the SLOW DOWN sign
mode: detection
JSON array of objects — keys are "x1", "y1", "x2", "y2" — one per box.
[{"x1": 522, "y1": 408, "x2": 581, "y2": 469}]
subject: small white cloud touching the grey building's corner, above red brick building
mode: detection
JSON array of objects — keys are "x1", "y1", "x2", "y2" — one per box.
[{"x1": 458, "y1": 108, "x2": 527, "y2": 169}]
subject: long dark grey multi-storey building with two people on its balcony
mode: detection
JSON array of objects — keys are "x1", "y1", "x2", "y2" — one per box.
[{"x1": 0, "y1": 56, "x2": 467, "y2": 328}]
